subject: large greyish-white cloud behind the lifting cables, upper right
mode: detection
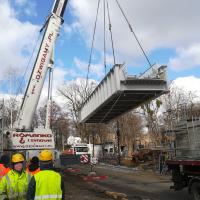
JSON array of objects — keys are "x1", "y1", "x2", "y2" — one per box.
[{"x1": 71, "y1": 0, "x2": 200, "y2": 68}]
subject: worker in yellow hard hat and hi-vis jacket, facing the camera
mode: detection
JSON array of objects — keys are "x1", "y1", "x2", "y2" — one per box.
[{"x1": 0, "y1": 153, "x2": 31, "y2": 200}]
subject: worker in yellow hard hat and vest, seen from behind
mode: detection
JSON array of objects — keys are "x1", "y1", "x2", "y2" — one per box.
[{"x1": 27, "y1": 150, "x2": 65, "y2": 200}]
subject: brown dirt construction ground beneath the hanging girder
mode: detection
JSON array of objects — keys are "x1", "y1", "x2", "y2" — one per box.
[{"x1": 63, "y1": 164, "x2": 190, "y2": 200}]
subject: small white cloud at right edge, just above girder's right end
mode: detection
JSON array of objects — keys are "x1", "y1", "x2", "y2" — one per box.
[{"x1": 169, "y1": 43, "x2": 200, "y2": 71}]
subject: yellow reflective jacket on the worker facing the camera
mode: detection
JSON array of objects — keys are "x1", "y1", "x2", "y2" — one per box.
[{"x1": 0, "y1": 170, "x2": 31, "y2": 200}]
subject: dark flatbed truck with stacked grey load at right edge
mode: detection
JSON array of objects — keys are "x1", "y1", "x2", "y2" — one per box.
[{"x1": 166, "y1": 116, "x2": 200, "y2": 200}]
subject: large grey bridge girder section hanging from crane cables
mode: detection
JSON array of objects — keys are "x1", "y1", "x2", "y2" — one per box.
[{"x1": 79, "y1": 65, "x2": 168, "y2": 123}]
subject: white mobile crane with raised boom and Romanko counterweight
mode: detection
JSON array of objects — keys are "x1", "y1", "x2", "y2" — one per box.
[{"x1": 7, "y1": 0, "x2": 68, "y2": 150}]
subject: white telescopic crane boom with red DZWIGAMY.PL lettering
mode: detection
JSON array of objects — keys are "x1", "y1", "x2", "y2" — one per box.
[{"x1": 17, "y1": 0, "x2": 68, "y2": 130}]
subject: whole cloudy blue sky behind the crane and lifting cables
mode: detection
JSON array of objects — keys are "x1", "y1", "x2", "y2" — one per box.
[{"x1": 0, "y1": 0, "x2": 200, "y2": 97}]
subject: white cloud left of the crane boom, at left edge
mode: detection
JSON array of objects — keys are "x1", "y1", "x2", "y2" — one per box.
[{"x1": 0, "y1": 0, "x2": 39, "y2": 80}]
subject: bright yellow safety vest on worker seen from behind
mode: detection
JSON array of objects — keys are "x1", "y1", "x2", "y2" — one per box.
[{"x1": 34, "y1": 170, "x2": 62, "y2": 200}]
